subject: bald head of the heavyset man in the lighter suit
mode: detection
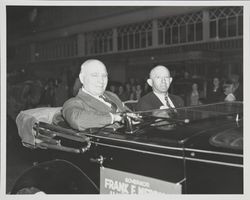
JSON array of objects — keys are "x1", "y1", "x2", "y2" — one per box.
[{"x1": 79, "y1": 59, "x2": 108, "y2": 96}]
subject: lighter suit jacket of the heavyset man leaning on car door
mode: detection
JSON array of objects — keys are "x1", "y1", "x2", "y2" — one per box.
[{"x1": 62, "y1": 89, "x2": 126, "y2": 130}]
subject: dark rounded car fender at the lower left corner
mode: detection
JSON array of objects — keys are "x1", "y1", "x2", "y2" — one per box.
[{"x1": 11, "y1": 159, "x2": 99, "y2": 194}]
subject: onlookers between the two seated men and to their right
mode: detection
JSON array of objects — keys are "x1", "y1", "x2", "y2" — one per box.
[{"x1": 102, "y1": 74, "x2": 243, "y2": 106}]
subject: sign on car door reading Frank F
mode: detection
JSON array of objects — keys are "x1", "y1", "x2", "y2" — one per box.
[{"x1": 100, "y1": 167, "x2": 182, "y2": 194}]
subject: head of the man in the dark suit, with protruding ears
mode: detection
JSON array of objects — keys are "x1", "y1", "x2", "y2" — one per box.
[{"x1": 147, "y1": 65, "x2": 172, "y2": 94}]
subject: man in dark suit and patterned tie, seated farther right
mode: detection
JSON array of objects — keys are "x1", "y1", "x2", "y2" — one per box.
[{"x1": 136, "y1": 65, "x2": 184, "y2": 111}]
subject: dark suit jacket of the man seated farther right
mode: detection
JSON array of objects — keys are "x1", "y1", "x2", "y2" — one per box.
[{"x1": 135, "y1": 92, "x2": 184, "y2": 111}]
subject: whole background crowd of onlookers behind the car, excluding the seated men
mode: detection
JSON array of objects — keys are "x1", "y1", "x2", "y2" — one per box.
[{"x1": 8, "y1": 62, "x2": 243, "y2": 122}]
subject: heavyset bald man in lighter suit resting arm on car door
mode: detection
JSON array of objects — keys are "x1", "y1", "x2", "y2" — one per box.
[{"x1": 62, "y1": 59, "x2": 130, "y2": 130}]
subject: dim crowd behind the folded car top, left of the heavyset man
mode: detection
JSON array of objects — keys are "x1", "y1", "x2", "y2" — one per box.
[{"x1": 7, "y1": 72, "x2": 72, "y2": 120}]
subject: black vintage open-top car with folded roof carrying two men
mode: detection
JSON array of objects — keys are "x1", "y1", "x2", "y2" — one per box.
[{"x1": 11, "y1": 102, "x2": 243, "y2": 194}]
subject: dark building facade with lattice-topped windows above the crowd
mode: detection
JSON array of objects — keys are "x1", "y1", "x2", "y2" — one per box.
[{"x1": 7, "y1": 6, "x2": 243, "y2": 82}]
